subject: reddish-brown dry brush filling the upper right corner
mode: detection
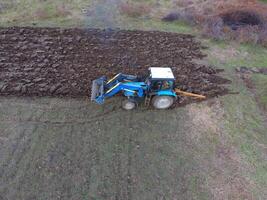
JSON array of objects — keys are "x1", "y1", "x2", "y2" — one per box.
[{"x1": 163, "y1": 0, "x2": 267, "y2": 46}]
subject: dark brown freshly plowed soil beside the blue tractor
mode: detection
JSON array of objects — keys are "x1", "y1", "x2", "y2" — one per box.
[{"x1": 0, "y1": 27, "x2": 228, "y2": 104}]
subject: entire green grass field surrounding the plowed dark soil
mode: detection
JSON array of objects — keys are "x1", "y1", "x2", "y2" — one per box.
[{"x1": 0, "y1": 0, "x2": 267, "y2": 200}]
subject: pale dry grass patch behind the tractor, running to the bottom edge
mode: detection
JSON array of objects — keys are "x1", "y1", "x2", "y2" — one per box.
[{"x1": 187, "y1": 99, "x2": 255, "y2": 200}]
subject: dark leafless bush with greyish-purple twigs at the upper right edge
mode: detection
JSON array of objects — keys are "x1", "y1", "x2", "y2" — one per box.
[{"x1": 203, "y1": 11, "x2": 267, "y2": 47}]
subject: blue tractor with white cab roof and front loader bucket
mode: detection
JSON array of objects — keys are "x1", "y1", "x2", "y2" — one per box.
[{"x1": 91, "y1": 67, "x2": 177, "y2": 110}]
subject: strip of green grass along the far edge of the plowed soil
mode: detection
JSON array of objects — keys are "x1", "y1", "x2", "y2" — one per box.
[{"x1": 0, "y1": 0, "x2": 195, "y2": 33}]
